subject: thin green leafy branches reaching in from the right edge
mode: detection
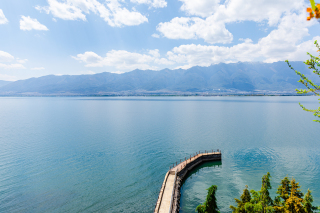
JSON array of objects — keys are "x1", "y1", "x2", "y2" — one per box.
[{"x1": 286, "y1": 41, "x2": 320, "y2": 122}]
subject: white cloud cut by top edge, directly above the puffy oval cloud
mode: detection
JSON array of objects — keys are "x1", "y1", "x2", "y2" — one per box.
[{"x1": 179, "y1": 0, "x2": 220, "y2": 17}]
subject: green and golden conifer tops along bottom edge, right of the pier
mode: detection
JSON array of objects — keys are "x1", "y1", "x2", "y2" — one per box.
[{"x1": 196, "y1": 172, "x2": 320, "y2": 213}]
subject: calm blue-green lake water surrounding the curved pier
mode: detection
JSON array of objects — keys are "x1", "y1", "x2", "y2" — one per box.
[{"x1": 0, "y1": 97, "x2": 320, "y2": 213}]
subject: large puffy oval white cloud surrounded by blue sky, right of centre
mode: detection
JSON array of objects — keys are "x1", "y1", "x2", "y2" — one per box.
[{"x1": 157, "y1": 17, "x2": 233, "y2": 44}]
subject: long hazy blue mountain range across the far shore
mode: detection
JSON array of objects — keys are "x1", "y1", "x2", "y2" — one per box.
[{"x1": 0, "y1": 62, "x2": 319, "y2": 95}]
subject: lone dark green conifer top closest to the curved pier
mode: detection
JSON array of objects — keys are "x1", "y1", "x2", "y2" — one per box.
[{"x1": 196, "y1": 185, "x2": 220, "y2": 213}]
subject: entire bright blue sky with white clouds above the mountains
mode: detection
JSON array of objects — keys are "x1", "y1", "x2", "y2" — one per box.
[{"x1": 0, "y1": 0, "x2": 320, "y2": 81}]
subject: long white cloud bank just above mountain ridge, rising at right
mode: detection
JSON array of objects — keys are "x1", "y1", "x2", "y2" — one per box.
[{"x1": 73, "y1": 10, "x2": 320, "y2": 72}]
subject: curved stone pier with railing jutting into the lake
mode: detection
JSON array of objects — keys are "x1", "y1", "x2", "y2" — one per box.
[{"x1": 154, "y1": 150, "x2": 221, "y2": 213}]
